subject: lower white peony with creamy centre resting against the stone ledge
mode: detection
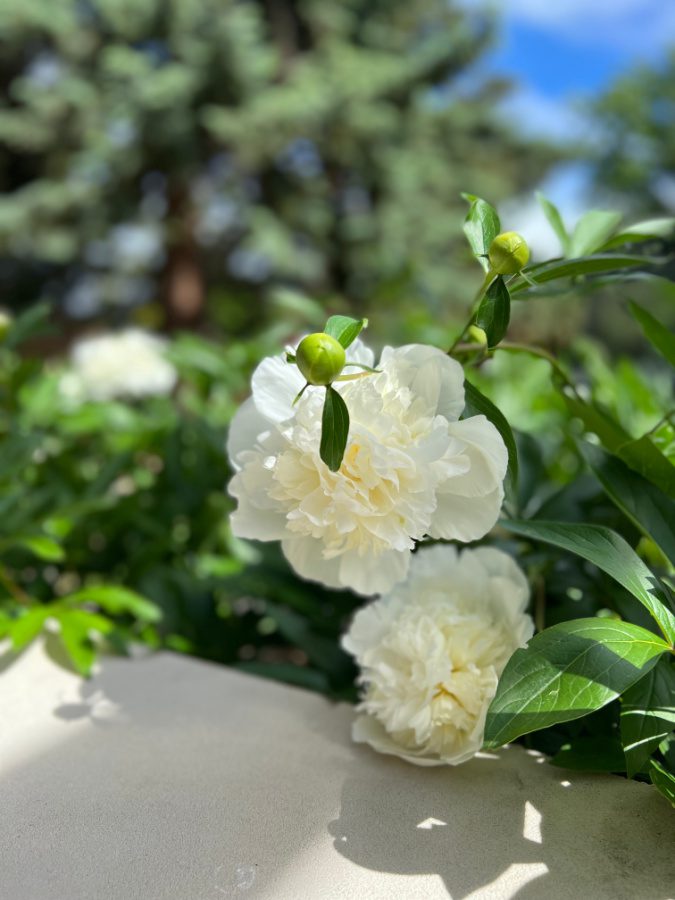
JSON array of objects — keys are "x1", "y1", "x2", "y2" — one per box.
[{"x1": 342, "y1": 545, "x2": 534, "y2": 766}]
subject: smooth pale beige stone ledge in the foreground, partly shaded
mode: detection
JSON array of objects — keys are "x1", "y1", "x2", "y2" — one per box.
[{"x1": 0, "y1": 647, "x2": 675, "y2": 900}]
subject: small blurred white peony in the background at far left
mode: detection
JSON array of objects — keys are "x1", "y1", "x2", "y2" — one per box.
[{"x1": 60, "y1": 328, "x2": 177, "y2": 403}]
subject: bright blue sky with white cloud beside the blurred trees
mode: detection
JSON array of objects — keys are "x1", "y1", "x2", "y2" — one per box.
[{"x1": 461, "y1": 0, "x2": 675, "y2": 256}]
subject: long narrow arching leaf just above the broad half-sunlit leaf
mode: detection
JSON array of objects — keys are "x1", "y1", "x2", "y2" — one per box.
[{"x1": 500, "y1": 519, "x2": 675, "y2": 645}]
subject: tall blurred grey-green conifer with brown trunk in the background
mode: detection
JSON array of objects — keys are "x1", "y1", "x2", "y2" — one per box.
[{"x1": 0, "y1": 0, "x2": 553, "y2": 329}]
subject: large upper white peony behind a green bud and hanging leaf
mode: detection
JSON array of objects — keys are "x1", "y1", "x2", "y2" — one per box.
[{"x1": 228, "y1": 341, "x2": 507, "y2": 596}]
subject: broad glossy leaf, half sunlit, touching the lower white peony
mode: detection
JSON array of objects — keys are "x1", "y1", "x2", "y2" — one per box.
[{"x1": 485, "y1": 619, "x2": 669, "y2": 747}]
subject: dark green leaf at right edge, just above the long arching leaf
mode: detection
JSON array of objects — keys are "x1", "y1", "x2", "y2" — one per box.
[{"x1": 579, "y1": 442, "x2": 675, "y2": 566}]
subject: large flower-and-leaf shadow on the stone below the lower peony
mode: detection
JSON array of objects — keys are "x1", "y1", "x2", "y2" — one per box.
[{"x1": 328, "y1": 747, "x2": 670, "y2": 900}]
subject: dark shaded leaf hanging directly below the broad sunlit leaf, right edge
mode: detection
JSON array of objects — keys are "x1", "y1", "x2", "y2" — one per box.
[{"x1": 621, "y1": 657, "x2": 675, "y2": 778}]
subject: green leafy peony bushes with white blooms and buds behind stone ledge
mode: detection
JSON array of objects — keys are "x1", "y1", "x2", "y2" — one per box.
[{"x1": 0, "y1": 195, "x2": 675, "y2": 799}]
